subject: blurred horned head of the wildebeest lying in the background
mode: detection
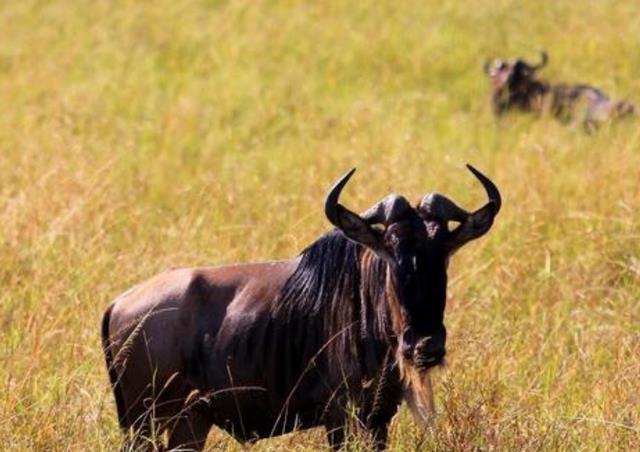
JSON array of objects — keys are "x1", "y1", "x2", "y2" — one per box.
[{"x1": 484, "y1": 51, "x2": 549, "y2": 114}]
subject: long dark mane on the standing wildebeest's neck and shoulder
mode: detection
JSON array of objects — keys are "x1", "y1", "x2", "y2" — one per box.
[{"x1": 273, "y1": 229, "x2": 390, "y2": 370}]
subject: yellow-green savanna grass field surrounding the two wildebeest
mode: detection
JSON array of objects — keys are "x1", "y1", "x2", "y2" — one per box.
[{"x1": 0, "y1": 0, "x2": 640, "y2": 451}]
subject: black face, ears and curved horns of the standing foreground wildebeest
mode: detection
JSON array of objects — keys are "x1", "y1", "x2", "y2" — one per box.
[{"x1": 325, "y1": 165, "x2": 501, "y2": 370}]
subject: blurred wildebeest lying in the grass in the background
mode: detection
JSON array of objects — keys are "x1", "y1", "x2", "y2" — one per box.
[{"x1": 484, "y1": 51, "x2": 635, "y2": 131}]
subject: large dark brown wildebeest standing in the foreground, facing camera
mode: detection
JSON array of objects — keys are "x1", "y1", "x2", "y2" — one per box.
[{"x1": 102, "y1": 165, "x2": 501, "y2": 449}]
